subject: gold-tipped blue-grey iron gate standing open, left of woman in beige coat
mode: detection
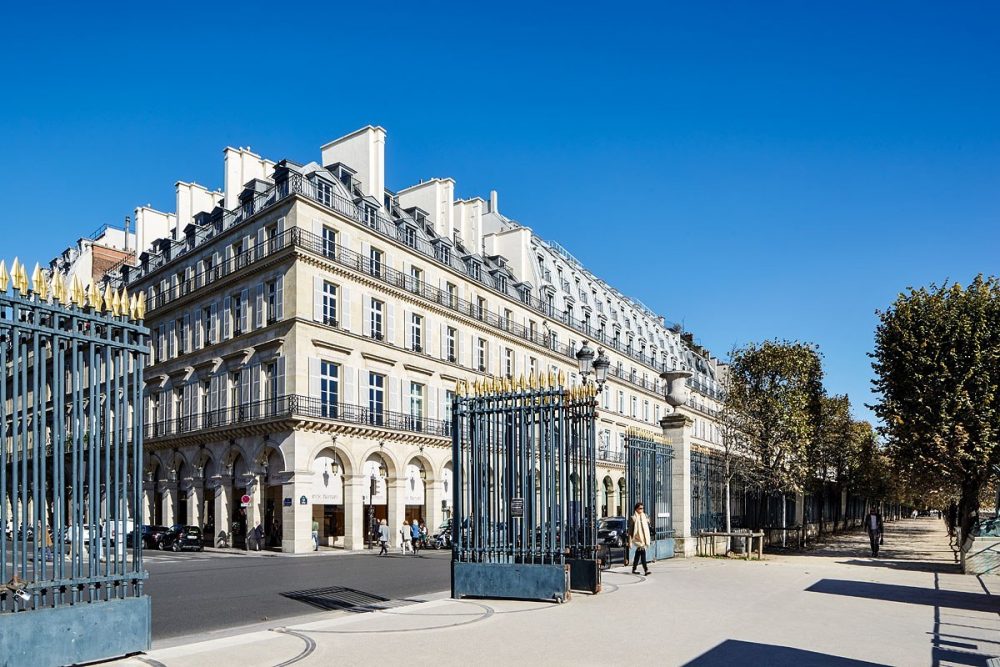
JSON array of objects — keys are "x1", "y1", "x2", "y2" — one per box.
[{"x1": 452, "y1": 374, "x2": 600, "y2": 601}]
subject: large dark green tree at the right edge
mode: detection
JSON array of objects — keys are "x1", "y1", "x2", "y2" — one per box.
[{"x1": 871, "y1": 275, "x2": 1000, "y2": 536}]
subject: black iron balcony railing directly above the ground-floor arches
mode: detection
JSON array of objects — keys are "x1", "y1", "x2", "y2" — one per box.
[{"x1": 146, "y1": 394, "x2": 451, "y2": 440}]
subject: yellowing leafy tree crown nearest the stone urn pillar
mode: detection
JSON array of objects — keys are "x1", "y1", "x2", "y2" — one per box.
[{"x1": 724, "y1": 341, "x2": 823, "y2": 544}]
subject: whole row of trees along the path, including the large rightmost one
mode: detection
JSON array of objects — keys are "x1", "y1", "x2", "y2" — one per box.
[{"x1": 720, "y1": 276, "x2": 1000, "y2": 548}]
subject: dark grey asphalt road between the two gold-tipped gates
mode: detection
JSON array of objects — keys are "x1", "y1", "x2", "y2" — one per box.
[{"x1": 145, "y1": 551, "x2": 451, "y2": 640}]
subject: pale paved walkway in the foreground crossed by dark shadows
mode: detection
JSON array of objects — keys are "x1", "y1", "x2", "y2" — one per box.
[{"x1": 115, "y1": 518, "x2": 1000, "y2": 667}]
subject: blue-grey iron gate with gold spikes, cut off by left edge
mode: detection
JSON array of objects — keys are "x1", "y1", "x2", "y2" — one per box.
[{"x1": 0, "y1": 260, "x2": 150, "y2": 665}]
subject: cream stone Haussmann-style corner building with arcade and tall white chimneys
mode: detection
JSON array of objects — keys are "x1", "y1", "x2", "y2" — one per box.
[{"x1": 115, "y1": 126, "x2": 723, "y2": 553}]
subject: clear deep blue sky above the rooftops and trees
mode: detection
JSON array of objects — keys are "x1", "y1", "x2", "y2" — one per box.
[{"x1": 0, "y1": 2, "x2": 1000, "y2": 422}]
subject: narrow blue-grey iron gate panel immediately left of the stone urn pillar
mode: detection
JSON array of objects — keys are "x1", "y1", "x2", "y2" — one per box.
[{"x1": 625, "y1": 429, "x2": 674, "y2": 560}]
